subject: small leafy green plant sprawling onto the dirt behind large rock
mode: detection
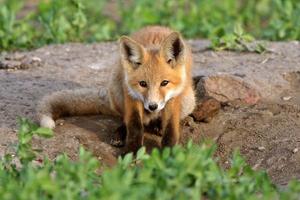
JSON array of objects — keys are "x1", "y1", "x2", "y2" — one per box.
[{"x1": 211, "y1": 24, "x2": 266, "y2": 53}]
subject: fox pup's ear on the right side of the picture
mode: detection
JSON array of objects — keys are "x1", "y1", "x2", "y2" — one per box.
[{"x1": 160, "y1": 32, "x2": 186, "y2": 65}]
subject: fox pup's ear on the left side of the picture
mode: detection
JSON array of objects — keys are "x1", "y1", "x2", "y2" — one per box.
[{"x1": 119, "y1": 36, "x2": 144, "y2": 69}]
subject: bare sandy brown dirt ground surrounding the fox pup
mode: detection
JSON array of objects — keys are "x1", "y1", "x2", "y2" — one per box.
[{"x1": 0, "y1": 40, "x2": 300, "y2": 185}]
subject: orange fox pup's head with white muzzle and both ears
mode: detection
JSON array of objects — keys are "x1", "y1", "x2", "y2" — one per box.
[{"x1": 120, "y1": 32, "x2": 186, "y2": 112}]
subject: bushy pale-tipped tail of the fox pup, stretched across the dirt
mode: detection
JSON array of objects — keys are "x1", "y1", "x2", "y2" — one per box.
[{"x1": 37, "y1": 89, "x2": 117, "y2": 129}]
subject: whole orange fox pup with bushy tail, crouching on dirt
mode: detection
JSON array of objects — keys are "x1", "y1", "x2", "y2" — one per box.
[{"x1": 37, "y1": 26, "x2": 195, "y2": 152}]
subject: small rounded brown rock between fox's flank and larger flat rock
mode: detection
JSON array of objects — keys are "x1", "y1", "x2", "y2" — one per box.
[{"x1": 192, "y1": 97, "x2": 221, "y2": 122}]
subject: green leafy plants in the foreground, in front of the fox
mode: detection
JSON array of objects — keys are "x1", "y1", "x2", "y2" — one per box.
[{"x1": 0, "y1": 119, "x2": 300, "y2": 200}]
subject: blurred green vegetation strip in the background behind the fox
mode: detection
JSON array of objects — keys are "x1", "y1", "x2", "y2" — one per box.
[{"x1": 0, "y1": 0, "x2": 300, "y2": 50}]
